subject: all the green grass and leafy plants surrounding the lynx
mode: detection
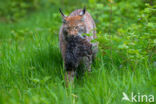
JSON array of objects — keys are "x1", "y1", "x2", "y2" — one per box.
[{"x1": 0, "y1": 0, "x2": 156, "y2": 104}]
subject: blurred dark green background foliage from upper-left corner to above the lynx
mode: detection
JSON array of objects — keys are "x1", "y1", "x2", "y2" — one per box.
[{"x1": 0, "y1": 0, "x2": 86, "y2": 22}]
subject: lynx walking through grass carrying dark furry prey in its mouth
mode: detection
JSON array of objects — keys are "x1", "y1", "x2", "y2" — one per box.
[{"x1": 59, "y1": 8, "x2": 97, "y2": 81}]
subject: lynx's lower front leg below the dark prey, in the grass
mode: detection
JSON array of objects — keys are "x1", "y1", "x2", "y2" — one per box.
[{"x1": 65, "y1": 70, "x2": 75, "y2": 87}]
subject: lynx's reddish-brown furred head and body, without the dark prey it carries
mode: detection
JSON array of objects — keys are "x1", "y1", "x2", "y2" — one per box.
[{"x1": 59, "y1": 9, "x2": 97, "y2": 85}]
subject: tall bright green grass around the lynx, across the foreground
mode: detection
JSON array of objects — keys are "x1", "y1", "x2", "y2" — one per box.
[{"x1": 0, "y1": 1, "x2": 156, "y2": 104}]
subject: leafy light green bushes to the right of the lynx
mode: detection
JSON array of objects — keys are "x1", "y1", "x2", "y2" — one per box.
[{"x1": 91, "y1": 3, "x2": 156, "y2": 67}]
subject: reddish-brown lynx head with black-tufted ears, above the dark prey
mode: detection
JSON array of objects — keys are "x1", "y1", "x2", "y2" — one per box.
[{"x1": 59, "y1": 8, "x2": 86, "y2": 38}]
